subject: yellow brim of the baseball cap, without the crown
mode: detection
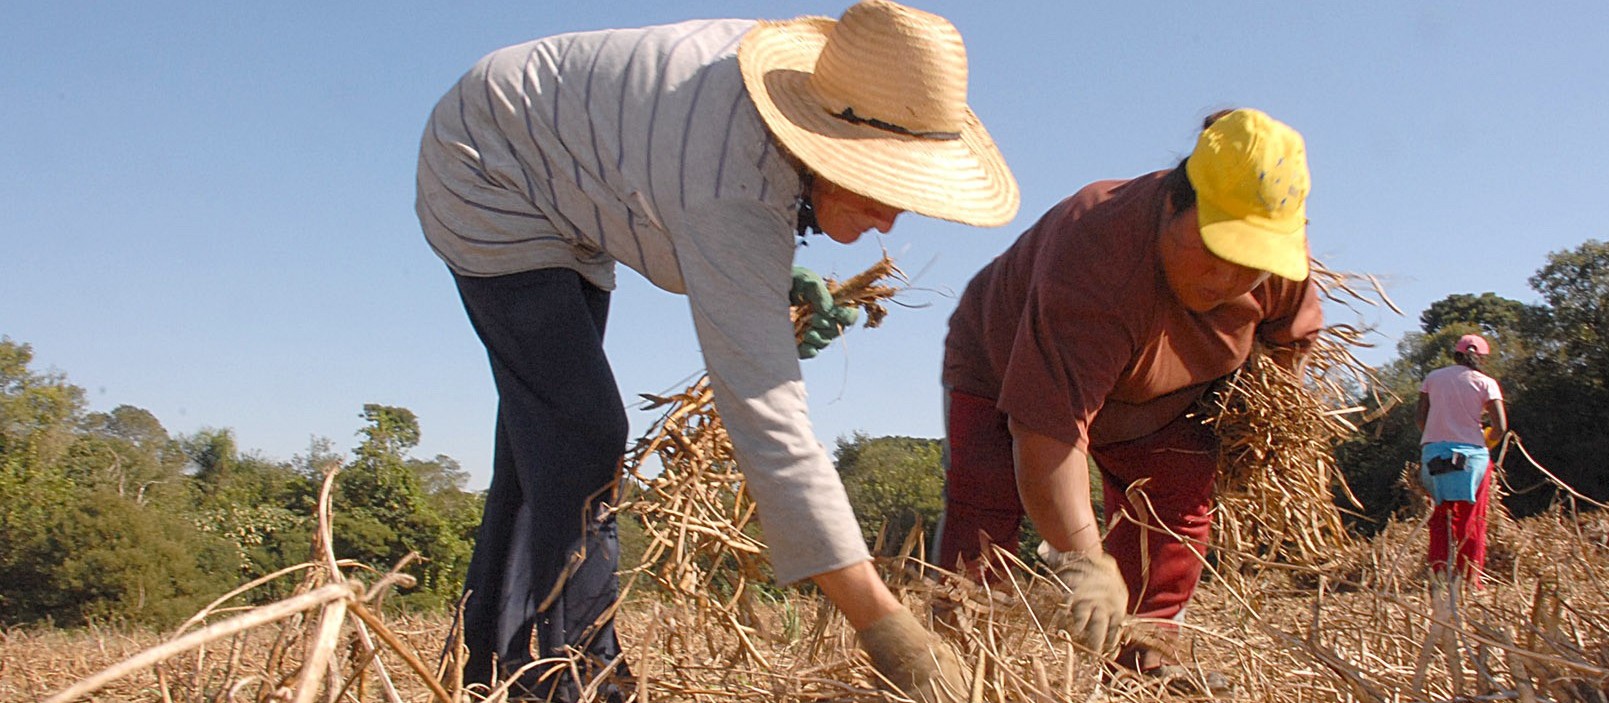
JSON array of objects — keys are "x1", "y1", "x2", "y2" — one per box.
[{"x1": 1195, "y1": 201, "x2": 1308, "y2": 282}]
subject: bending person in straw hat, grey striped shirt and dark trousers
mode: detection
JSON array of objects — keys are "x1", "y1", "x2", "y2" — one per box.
[{"x1": 417, "y1": 0, "x2": 1018, "y2": 700}]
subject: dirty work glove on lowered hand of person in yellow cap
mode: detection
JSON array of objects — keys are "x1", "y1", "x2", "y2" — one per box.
[{"x1": 1039, "y1": 542, "x2": 1128, "y2": 653}]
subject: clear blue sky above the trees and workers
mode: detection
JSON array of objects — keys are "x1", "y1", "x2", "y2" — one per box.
[{"x1": 0, "y1": 0, "x2": 1609, "y2": 487}]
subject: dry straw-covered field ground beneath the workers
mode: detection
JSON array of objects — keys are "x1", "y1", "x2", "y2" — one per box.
[{"x1": 9, "y1": 501, "x2": 1609, "y2": 701}]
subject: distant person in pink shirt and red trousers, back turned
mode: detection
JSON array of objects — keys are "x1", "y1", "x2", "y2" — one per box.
[{"x1": 1416, "y1": 335, "x2": 1508, "y2": 589}]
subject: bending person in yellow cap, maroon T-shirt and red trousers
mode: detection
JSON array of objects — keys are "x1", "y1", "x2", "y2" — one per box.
[{"x1": 936, "y1": 109, "x2": 1323, "y2": 687}]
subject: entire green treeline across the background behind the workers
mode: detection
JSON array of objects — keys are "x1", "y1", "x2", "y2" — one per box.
[{"x1": 0, "y1": 241, "x2": 1609, "y2": 626}]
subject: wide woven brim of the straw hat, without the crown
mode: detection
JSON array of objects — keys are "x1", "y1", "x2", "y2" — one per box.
[{"x1": 737, "y1": 18, "x2": 1022, "y2": 227}]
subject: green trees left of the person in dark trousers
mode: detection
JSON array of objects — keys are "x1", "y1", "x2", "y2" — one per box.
[{"x1": 0, "y1": 339, "x2": 481, "y2": 626}]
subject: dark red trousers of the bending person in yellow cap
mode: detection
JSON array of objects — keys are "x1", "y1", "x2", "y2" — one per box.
[{"x1": 938, "y1": 391, "x2": 1218, "y2": 618}]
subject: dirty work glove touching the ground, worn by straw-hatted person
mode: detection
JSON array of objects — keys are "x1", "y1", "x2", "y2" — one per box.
[{"x1": 861, "y1": 608, "x2": 969, "y2": 703}]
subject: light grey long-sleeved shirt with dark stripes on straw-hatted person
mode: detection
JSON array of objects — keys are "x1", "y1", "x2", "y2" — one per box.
[{"x1": 417, "y1": 19, "x2": 867, "y2": 582}]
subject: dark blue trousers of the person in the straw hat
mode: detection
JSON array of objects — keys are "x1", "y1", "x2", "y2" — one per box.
[{"x1": 454, "y1": 269, "x2": 629, "y2": 700}]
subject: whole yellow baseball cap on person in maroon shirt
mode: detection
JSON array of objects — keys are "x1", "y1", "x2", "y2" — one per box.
[{"x1": 1184, "y1": 109, "x2": 1310, "y2": 280}]
